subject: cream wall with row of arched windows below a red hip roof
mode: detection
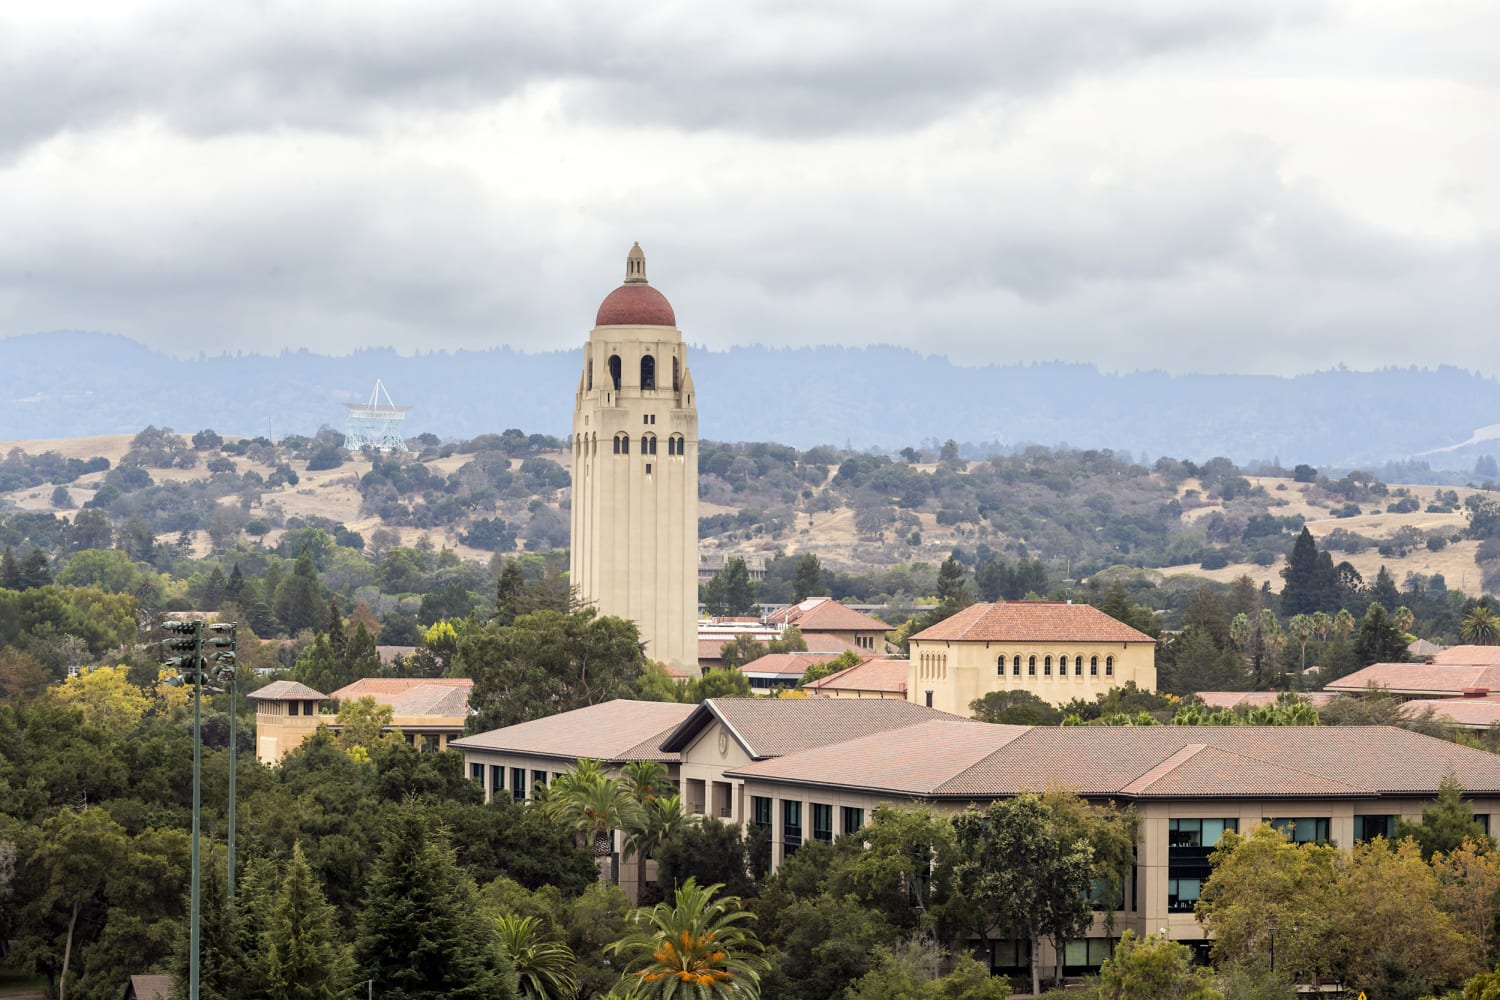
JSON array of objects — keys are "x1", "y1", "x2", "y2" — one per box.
[{"x1": 906, "y1": 639, "x2": 1157, "y2": 715}]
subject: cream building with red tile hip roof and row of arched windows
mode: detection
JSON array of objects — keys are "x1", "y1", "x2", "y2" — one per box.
[{"x1": 906, "y1": 601, "x2": 1157, "y2": 715}]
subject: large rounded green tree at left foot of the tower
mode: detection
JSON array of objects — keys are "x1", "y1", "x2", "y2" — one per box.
[{"x1": 455, "y1": 607, "x2": 647, "y2": 733}]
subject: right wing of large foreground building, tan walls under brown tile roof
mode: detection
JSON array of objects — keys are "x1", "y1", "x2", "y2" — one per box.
[{"x1": 717, "y1": 718, "x2": 1500, "y2": 975}]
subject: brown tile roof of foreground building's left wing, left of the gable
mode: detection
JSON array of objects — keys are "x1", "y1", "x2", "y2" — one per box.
[{"x1": 449, "y1": 699, "x2": 696, "y2": 762}]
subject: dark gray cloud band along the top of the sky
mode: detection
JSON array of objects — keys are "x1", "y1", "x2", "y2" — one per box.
[{"x1": 0, "y1": 0, "x2": 1320, "y2": 148}]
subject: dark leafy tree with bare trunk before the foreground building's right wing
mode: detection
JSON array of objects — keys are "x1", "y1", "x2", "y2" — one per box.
[{"x1": 953, "y1": 792, "x2": 1095, "y2": 994}]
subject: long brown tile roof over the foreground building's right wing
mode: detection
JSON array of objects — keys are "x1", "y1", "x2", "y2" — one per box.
[{"x1": 728, "y1": 722, "x2": 1500, "y2": 799}]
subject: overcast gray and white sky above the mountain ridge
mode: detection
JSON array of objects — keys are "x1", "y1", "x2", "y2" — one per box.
[{"x1": 0, "y1": 0, "x2": 1500, "y2": 375}]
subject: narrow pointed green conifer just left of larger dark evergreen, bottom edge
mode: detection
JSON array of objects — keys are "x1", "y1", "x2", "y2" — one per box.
[{"x1": 264, "y1": 843, "x2": 354, "y2": 1000}]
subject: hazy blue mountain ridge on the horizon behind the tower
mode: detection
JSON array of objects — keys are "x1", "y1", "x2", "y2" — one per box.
[{"x1": 0, "y1": 331, "x2": 1500, "y2": 469}]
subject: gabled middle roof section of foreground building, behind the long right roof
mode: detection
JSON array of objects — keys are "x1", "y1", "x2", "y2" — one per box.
[{"x1": 662, "y1": 697, "x2": 978, "y2": 760}]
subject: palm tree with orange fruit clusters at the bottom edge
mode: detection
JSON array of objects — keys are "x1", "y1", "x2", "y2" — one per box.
[{"x1": 605, "y1": 879, "x2": 767, "y2": 1000}]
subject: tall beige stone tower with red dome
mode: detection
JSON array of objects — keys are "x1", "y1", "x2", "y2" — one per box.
[{"x1": 569, "y1": 243, "x2": 698, "y2": 675}]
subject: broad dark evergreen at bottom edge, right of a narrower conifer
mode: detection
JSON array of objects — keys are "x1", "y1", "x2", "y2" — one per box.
[{"x1": 357, "y1": 808, "x2": 518, "y2": 1000}]
